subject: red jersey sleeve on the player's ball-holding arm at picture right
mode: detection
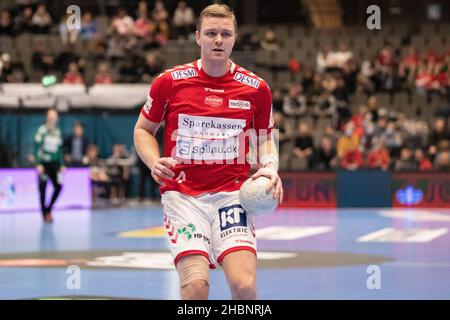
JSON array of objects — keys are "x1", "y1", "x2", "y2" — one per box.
[{"x1": 253, "y1": 83, "x2": 273, "y2": 133}]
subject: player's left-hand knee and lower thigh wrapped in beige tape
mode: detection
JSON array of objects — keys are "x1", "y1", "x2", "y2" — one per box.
[{"x1": 177, "y1": 255, "x2": 209, "y2": 299}]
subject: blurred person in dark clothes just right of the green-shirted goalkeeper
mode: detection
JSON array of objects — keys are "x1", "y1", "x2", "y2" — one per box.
[{"x1": 64, "y1": 121, "x2": 89, "y2": 167}]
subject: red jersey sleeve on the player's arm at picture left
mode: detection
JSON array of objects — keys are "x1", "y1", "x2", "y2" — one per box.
[{"x1": 141, "y1": 73, "x2": 172, "y2": 123}]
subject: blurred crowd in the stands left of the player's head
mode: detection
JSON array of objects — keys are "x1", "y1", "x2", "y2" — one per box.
[{"x1": 0, "y1": 0, "x2": 196, "y2": 84}]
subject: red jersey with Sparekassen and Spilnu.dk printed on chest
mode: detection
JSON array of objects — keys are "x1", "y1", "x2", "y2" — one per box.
[{"x1": 141, "y1": 60, "x2": 273, "y2": 195}]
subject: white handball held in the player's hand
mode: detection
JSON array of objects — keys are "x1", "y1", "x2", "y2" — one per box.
[{"x1": 239, "y1": 177, "x2": 278, "y2": 216}]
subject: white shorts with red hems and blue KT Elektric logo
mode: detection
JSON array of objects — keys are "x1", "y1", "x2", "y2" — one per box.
[{"x1": 161, "y1": 191, "x2": 256, "y2": 268}]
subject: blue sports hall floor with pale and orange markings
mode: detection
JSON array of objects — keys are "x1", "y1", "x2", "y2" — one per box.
[{"x1": 0, "y1": 206, "x2": 450, "y2": 300}]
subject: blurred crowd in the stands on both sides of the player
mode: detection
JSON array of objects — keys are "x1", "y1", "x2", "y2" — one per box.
[{"x1": 0, "y1": 1, "x2": 450, "y2": 175}]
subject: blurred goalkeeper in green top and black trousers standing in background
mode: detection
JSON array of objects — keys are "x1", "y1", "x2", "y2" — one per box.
[{"x1": 34, "y1": 109, "x2": 65, "y2": 223}]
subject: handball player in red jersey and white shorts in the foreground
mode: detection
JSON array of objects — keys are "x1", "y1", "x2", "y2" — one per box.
[{"x1": 134, "y1": 4, "x2": 283, "y2": 299}]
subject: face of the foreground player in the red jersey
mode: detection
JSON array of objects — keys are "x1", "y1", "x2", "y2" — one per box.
[{"x1": 195, "y1": 17, "x2": 236, "y2": 61}]
